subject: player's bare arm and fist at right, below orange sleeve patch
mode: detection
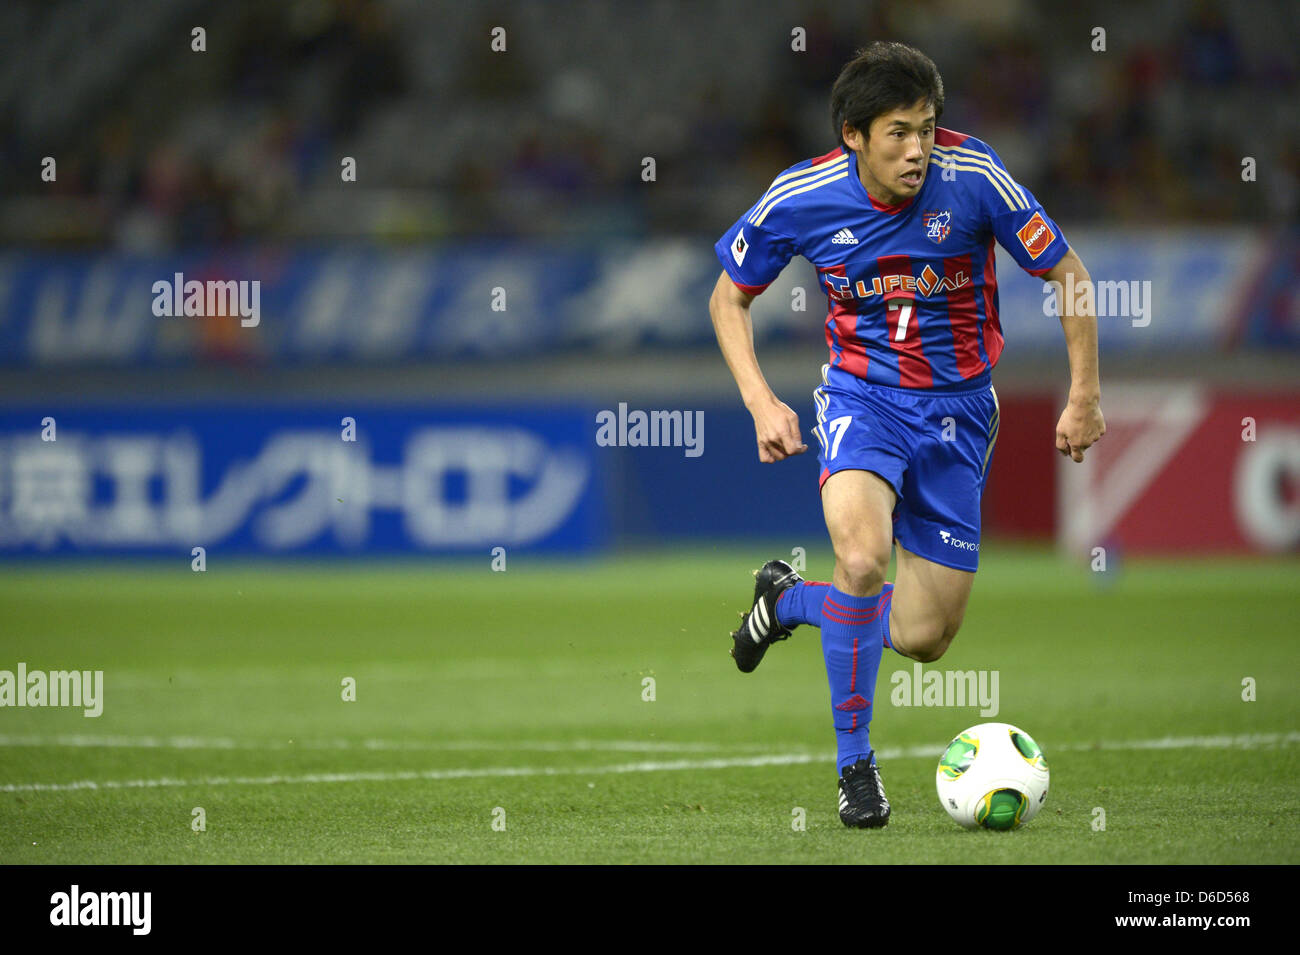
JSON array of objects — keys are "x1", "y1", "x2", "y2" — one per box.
[{"x1": 1043, "y1": 248, "x2": 1106, "y2": 461}]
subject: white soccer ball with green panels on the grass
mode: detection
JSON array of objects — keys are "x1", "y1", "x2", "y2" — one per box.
[{"x1": 935, "y1": 722, "x2": 1048, "y2": 829}]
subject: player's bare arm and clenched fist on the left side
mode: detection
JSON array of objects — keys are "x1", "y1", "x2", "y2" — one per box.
[{"x1": 709, "y1": 272, "x2": 807, "y2": 463}]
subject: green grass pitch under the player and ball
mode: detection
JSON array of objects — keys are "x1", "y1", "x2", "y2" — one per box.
[{"x1": 0, "y1": 547, "x2": 1300, "y2": 864}]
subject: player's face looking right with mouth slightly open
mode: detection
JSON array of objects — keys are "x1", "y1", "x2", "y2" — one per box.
[{"x1": 844, "y1": 100, "x2": 935, "y2": 205}]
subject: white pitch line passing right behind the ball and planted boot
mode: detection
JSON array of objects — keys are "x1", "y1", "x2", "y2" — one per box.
[{"x1": 0, "y1": 732, "x2": 1300, "y2": 793}]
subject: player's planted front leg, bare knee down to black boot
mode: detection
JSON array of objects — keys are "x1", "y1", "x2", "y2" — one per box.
[{"x1": 822, "y1": 469, "x2": 896, "y2": 828}]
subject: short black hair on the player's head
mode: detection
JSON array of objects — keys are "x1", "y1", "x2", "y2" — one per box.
[{"x1": 831, "y1": 40, "x2": 944, "y2": 146}]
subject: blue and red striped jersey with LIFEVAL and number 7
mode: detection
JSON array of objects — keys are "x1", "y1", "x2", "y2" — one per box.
[{"x1": 715, "y1": 127, "x2": 1069, "y2": 388}]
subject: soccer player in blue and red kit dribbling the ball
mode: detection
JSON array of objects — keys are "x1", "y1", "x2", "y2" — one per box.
[{"x1": 709, "y1": 42, "x2": 1105, "y2": 828}]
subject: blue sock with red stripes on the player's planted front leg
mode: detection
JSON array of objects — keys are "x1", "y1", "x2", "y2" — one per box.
[{"x1": 822, "y1": 586, "x2": 889, "y2": 773}]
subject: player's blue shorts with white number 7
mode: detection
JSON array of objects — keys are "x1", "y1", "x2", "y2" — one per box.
[{"x1": 813, "y1": 365, "x2": 998, "y2": 573}]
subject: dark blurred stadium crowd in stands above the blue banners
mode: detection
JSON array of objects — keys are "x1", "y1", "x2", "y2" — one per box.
[{"x1": 0, "y1": 0, "x2": 1300, "y2": 252}]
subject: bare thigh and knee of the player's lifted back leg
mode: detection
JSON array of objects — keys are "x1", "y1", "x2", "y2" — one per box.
[{"x1": 888, "y1": 544, "x2": 975, "y2": 663}]
